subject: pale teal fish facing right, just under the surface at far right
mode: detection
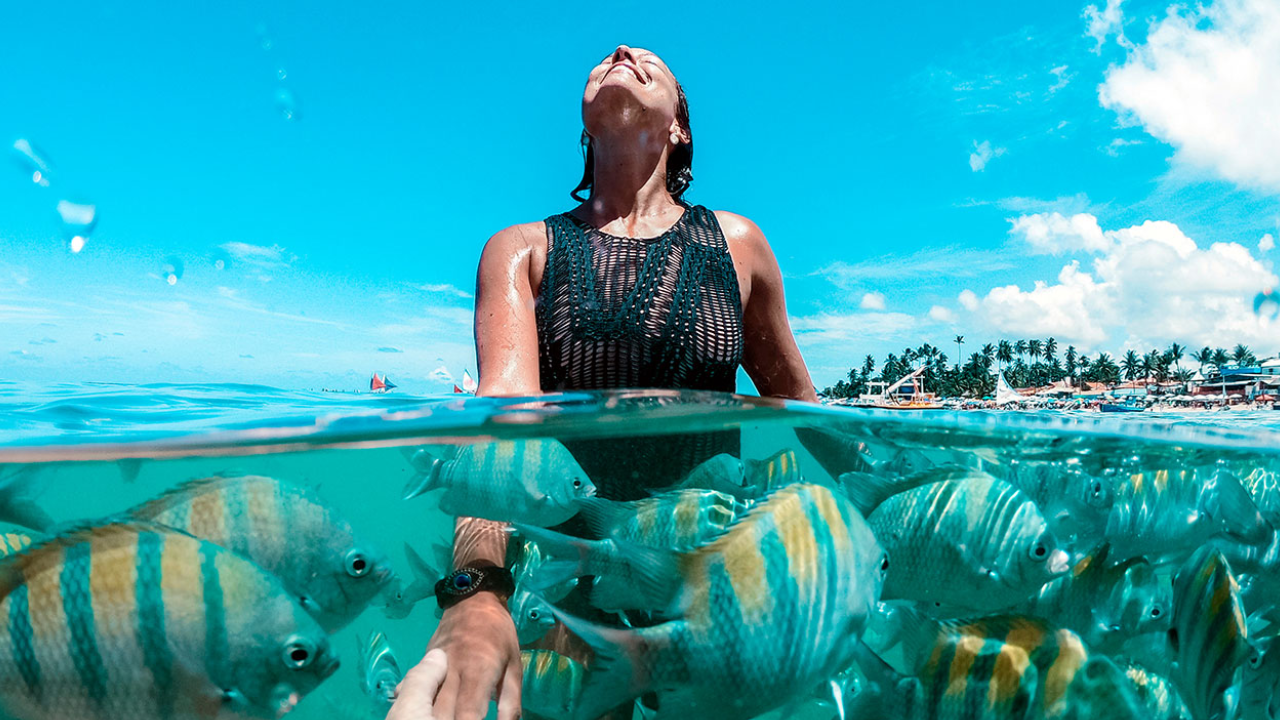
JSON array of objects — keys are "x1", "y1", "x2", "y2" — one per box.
[{"x1": 1103, "y1": 468, "x2": 1275, "y2": 565}]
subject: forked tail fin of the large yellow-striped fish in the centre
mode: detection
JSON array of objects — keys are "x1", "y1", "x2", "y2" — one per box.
[{"x1": 552, "y1": 606, "x2": 667, "y2": 720}]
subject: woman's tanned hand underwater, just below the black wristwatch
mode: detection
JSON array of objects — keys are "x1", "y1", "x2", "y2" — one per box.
[{"x1": 424, "y1": 592, "x2": 524, "y2": 720}]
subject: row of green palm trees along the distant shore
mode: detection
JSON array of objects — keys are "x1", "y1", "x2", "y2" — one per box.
[{"x1": 822, "y1": 336, "x2": 1258, "y2": 397}]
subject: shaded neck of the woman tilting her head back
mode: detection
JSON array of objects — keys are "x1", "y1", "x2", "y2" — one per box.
[{"x1": 584, "y1": 131, "x2": 680, "y2": 224}]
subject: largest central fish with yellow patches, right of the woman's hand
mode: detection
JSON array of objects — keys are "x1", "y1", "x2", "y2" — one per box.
[{"x1": 545, "y1": 483, "x2": 888, "y2": 720}]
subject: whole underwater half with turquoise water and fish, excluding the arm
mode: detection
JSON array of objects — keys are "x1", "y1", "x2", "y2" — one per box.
[{"x1": 0, "y1": 383, "x2": 1280, "y2": 720}]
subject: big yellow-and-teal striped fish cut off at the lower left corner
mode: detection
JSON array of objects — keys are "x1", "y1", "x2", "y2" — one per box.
[{"x1": 0, "y1": 524, "x2": 338, "y2": 720}]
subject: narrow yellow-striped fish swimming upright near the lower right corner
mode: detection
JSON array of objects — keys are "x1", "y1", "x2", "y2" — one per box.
[{"x1": 1169, "y1": 546, "x2": 1249, "y2": 719}]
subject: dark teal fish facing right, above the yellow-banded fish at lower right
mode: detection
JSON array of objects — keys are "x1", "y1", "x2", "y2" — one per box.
[{"x1": 1016, "y1": 543, "x2": 1172, "y2": 652}]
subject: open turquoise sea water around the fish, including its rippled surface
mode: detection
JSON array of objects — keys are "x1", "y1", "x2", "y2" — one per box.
[{"x1": 0, "y1": 383, "x2": 1280, "y2": 719}]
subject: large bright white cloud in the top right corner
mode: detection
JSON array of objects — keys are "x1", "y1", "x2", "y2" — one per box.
[{"x1": 1098, "y1": 0, "x2": 1280, "y2": 192}]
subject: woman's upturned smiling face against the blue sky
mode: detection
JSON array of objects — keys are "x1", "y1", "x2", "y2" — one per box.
[{"x1": 582, "y1": 45, "x2": 687, "y2": 142}]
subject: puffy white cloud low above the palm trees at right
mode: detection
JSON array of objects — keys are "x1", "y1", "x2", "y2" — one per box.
[{"x1": 961, "y1": 215, "x2": 1276, "y2": 347}]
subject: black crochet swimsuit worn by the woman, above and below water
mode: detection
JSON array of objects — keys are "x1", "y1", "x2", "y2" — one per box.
[{"x1": 536, "y1": 205, "x2": 742, "y2": 500}]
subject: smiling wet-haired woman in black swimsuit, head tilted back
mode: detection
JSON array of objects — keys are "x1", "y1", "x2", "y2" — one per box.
[{"x1": 388, "y1": 45, "x2": 817, "y2": 720}]
